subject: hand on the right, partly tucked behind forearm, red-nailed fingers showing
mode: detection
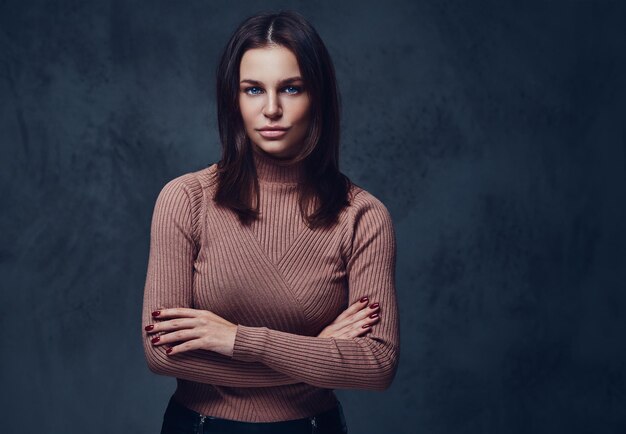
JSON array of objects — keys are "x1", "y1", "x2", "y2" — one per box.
[{"x1": 317, "y1": 297, "x2": 380, "y2": 339}]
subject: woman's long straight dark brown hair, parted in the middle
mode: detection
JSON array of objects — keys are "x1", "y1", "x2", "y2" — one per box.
[{"x1": 214, "y1": 11, "x2": 351, "y2": 228}]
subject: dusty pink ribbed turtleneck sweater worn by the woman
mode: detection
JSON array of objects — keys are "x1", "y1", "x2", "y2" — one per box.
[{"x1": 142, "y1": 153, "x2": 399, "y2": 422}]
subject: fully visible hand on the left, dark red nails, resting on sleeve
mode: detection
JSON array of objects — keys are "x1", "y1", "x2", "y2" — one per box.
[{"x1": 145, "y1": 307, "x2": 237, "y2": 357}]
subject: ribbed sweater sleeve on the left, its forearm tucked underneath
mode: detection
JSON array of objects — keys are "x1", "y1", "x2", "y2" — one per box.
[{"x1": 142, "y1": 174, "x2": 300, "y2": 387}]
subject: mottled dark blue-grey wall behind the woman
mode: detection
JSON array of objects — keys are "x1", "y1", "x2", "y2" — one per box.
[{"x1": 0, "y1": 0, "x2": 626, "y2": 434}]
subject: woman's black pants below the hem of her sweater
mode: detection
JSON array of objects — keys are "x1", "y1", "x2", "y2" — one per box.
[{"x1": 161, "y1": 396, "x2": 348, "y2": 434}]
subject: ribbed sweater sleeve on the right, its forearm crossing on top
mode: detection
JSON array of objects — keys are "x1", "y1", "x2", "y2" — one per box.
[{"x1": 233, "y1": 190, "x2": 400, "y2": 390}]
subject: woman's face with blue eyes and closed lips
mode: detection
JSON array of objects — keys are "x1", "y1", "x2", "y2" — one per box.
[{"x1": 239, "y1": 46, "x2": 310, "y2": 159}]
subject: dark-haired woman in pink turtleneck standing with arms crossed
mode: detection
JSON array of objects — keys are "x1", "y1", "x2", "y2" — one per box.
[{"x1": 143, "y1": 11, "x2": 399, "y2": 434}]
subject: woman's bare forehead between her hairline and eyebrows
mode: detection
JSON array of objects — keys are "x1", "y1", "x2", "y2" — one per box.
[{"x1": 239, "y1": 45, "x2": 300, "y2": 83}]
